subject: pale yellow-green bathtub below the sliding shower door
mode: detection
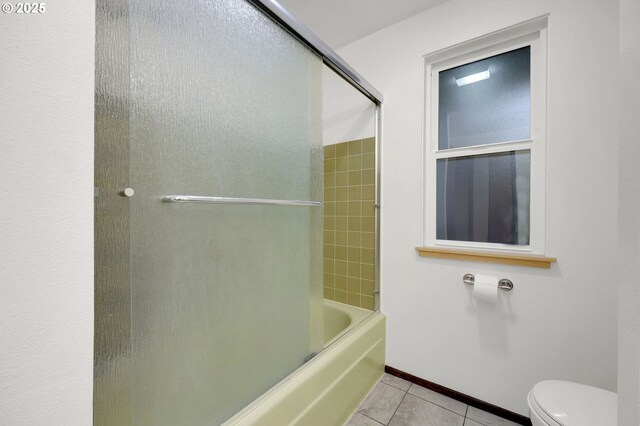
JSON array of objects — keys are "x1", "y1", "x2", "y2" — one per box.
[{"x1": 224, "y1": 300, "x2": 386, "y2": 426}]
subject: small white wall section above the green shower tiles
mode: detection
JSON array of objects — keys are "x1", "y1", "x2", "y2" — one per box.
[{"x1": 322, "y1": 66, "x2": 375, "y2": 145}]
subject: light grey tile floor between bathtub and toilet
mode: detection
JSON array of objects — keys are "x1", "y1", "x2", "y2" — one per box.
[{"x1": 346, "y1": 373, "x2": 518, "y2": 426}]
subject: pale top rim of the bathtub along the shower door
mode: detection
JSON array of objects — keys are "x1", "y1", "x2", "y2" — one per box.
[{"x1": 221, "y1": 302, "x2": 382, "y2": 426}]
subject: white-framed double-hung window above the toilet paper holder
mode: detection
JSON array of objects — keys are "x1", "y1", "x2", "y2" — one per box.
[{"x1": 425, "y1": 17, "x2": 547, "y2": 255}]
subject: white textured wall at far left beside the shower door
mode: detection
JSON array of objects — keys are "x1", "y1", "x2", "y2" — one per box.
[{"x1": 0, "y1": 0, "x2": 94, "y2": 425}]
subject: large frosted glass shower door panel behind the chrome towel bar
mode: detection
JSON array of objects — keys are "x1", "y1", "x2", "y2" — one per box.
[{"x1": 129, "y1": 0, "x2": 322, "y2": 425}]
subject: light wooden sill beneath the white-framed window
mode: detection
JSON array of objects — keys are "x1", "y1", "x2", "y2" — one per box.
[{"x1": 416, "y1": 247, "x2": 557, "y2": 269}]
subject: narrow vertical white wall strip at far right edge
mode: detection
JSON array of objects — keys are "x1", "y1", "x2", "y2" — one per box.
[{"x1": 618, "y1": 0, "x2": 640, "y2": 426}]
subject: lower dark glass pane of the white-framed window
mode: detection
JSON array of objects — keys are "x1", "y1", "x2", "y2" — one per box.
[{"x1": 436, "y1": 150, "x2": 531, "y2": 245}]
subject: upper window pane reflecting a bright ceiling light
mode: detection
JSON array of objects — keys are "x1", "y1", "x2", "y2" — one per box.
[{"x1": 438, "y1": 46, "x2": 531, "y2": 149}]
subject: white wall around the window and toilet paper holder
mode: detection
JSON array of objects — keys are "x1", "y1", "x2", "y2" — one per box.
[{"x1": 338, "y1": 0, "x2": 618, "y2": 415}]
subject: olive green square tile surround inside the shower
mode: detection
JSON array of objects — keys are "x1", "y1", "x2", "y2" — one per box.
[{"x1": 324, "y1": 138, "x2": 375, "y2": 310}]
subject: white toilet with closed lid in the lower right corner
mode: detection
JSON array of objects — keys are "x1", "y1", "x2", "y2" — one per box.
[{"x1": 527, "y1": 380, "x2": 618, "y2": 426}]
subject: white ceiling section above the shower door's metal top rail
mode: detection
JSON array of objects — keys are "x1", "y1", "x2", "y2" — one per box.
[{"x1": 277, "y1": 0, "x2": 447, "y2": 50}]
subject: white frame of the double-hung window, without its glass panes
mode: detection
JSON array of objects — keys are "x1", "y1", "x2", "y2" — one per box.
[{"x1": 423, "y1": 15, "x2": 548, "y2": 255}]
